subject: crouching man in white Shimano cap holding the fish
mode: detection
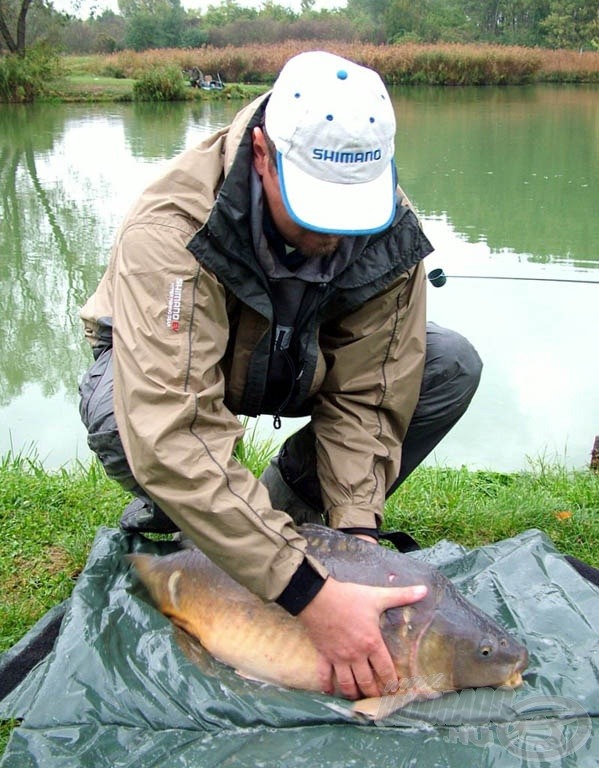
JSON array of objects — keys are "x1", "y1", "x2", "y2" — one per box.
[{"x1": 81, "y1": 52, "x2": 480, "y2": 698}]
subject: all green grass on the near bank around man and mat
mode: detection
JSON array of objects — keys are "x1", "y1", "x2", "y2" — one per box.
[{"x1": 0, "y1": 440, "x2": 599, "y2": 754}]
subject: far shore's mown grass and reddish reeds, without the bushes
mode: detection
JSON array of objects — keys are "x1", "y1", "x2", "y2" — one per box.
[{"x1": 37, "y1": 41, "x2": 599, "y2": 102}]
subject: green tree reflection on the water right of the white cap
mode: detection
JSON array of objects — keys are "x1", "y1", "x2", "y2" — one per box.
[{"x1": 396, "y1": 86, "x2": 599, "y2": 266}]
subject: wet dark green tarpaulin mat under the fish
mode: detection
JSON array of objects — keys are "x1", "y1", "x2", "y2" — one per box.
[{"x1": 0, "y1": 529, "x2": 599, "y2": 768}]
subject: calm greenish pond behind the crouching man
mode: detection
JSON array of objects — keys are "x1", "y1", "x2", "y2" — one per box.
[{"x1": 0, "y1": 86, "x2": 599, "y2": 471}]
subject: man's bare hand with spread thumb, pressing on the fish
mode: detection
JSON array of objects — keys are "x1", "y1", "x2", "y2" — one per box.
[{"x1": 298, "y1": 576, "x2": 427, "y2": 699}]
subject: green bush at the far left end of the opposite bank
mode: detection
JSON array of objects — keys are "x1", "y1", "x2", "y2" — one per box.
[{"x1": 0, "y1": 48, "x2": 59, "y2": 102}]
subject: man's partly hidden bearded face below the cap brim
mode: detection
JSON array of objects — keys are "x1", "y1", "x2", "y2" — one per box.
[{"x1": 252, "y1": 128, "x2": 341, "y2": 258}]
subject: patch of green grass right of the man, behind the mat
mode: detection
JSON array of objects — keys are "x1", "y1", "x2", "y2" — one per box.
[{"x1": 385, "y1": 461, "x2": 599, "y2": 567}]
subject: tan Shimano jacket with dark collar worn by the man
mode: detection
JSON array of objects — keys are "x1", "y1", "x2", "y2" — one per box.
[{"x1": 81, "y1": 97, "x2": 431, "y2": 600}]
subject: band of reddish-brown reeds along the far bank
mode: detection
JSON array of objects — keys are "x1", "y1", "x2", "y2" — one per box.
[{"x1": 73, "y1": 41, "x2": 599, "y2": 85}]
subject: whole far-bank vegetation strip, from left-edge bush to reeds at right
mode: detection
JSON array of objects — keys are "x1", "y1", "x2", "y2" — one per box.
[{"x1": 0, "y1": 40, "x2": 599, "y2": 102}]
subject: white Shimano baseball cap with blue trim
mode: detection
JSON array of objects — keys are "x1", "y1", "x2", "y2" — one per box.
[{"x1": 265, "y1": 51, "x2": 396, "y2": 235}]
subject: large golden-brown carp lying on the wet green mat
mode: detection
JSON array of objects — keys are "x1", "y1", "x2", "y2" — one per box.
[{"x1": 129, "y1": 525, "x2": 528, "y2": 719}]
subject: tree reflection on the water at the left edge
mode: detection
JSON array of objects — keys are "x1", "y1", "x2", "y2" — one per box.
[{"x1": 0, "y1": 106, "x2": 100, "y2": 414}]
